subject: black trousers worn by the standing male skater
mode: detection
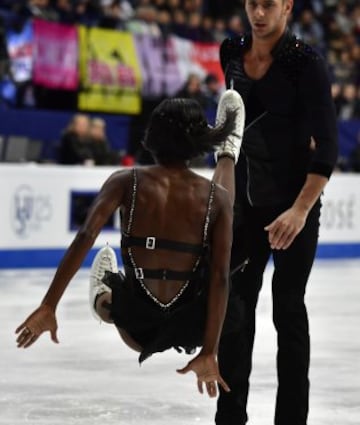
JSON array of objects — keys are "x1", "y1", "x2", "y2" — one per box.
[{"x1": 215, "y1": 201, "x2": 320, "y2": 425}]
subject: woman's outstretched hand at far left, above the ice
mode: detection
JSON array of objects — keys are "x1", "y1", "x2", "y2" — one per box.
[{"x1": 15, "y1": 305, "x2": 59, "y2": 348}]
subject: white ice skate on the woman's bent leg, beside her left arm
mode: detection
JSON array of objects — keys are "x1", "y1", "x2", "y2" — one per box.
[{"x1": 89, "y1": 245, "x2": 118, "y2": 322}]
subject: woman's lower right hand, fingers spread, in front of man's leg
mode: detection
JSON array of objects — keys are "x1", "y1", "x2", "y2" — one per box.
[{"x1": 177, "y1": 354, "x2": 230, "y2": 397}]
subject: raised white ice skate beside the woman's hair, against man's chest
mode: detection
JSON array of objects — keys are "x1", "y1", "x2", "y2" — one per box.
[{"x1": 215, "y1": 89, "x2": 245, "y2": 164}]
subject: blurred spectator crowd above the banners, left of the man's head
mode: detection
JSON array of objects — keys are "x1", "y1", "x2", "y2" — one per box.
[{"x1": 0, "y1": 0, "x2": 242, "y2": 41}]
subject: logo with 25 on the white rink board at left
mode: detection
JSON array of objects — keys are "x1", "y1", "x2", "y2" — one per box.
[{"x1": 11, "y1": 185, "x2": 52, "y2": 238}]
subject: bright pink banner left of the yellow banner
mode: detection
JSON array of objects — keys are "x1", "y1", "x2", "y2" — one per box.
[{"x1": 33, "y1": 19, "x2": 79, "y2": 90}]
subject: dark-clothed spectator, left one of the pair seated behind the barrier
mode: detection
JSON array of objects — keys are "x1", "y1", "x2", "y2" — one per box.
[{"x1": 59, "y1": 114, "x2": 95, "y2": 165}]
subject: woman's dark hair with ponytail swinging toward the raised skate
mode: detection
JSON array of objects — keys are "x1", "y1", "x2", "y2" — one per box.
[{"x1": 143, "y1": 98, "x2": 236, "y2": 164}]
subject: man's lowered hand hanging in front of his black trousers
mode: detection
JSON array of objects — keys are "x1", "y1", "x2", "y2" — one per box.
[{"x1": 264, "y1": 207, "x2": 307, "y2": 249}]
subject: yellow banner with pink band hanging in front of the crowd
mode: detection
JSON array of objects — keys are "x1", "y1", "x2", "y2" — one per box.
[{"x1": 78, "y1": 27, "x2": 141, "y2": 114}]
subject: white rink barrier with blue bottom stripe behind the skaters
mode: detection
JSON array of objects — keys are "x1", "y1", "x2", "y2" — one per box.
[{"x1": 0, "y1": 164, "x2": 360, "y2": 268}]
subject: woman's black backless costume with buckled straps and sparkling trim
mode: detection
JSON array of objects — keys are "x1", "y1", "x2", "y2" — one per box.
[{"x1": 104, "y1": 169, "x2": 225, "y2": 362}]
